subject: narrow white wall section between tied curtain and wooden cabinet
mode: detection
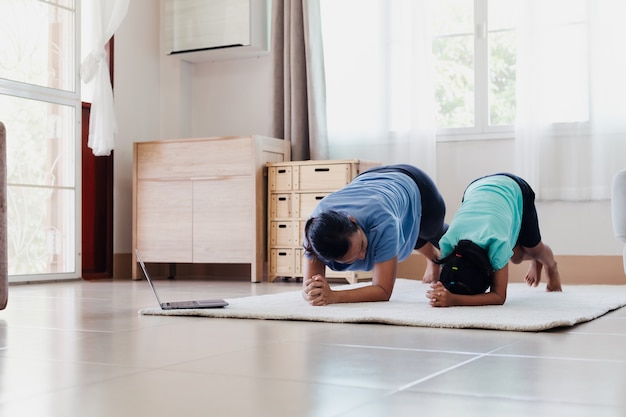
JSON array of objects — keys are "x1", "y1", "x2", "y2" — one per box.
[{"x1": 113, "y1": 0, "x2": 160, "y2": 254}]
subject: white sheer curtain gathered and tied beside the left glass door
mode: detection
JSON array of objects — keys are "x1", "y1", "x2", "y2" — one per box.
[{"x1": 80, "y1": 0, "x2": 130, "y2": 156}]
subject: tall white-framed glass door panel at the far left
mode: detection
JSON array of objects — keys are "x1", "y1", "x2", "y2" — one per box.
[{"x1": 0, "y1": 0, "x2": 81, "y2": 282}]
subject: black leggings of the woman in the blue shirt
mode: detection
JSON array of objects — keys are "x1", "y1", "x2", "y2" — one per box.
[{"x1": 360, "y1": 164, "x2": 448, "y2": 249}]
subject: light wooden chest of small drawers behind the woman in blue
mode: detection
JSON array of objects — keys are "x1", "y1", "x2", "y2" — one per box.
[{"x1": 267, "y1": 160, "x2": 380, "y2": 283}]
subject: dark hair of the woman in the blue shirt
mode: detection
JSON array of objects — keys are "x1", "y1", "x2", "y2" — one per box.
[{"x1": 303, "y1": 210, "x2": 358, "y2": 262}]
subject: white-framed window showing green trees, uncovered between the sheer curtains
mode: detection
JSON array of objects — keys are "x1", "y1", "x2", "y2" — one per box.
[{"x1": 431, "y1": 0, "x2": 515, "y2": 132}]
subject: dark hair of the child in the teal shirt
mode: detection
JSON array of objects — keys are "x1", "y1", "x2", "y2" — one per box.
[{"x1": 435, "y1": 239, "x2": 494, "y2": 295}]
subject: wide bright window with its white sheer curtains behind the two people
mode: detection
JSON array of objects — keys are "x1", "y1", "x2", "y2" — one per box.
[{"x1": 321, "y1": 0, "x2": 626, "y2": 200}]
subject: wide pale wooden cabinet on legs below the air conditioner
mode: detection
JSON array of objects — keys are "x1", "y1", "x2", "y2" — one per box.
[{"x1": 132, "y1": 135, "x2": 290, "y2": 282}]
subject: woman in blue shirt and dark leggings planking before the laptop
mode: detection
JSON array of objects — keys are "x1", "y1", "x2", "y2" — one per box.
[{"x1": 302, "y1": 164, "x2": 446, "y2": 305}]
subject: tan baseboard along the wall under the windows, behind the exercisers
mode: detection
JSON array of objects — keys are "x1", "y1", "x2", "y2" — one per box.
[{"x1": 398, "y1": 254, "x2": 626, "y2": 285}]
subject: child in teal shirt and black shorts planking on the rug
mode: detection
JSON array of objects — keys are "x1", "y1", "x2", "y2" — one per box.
[{"x1": 426, "y1": 173, "x2": 561, "y2": 307}]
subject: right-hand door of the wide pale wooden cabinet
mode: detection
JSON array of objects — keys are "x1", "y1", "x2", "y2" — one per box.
[{"x1": 193, "y1": 176, "x2": 251, "y2": 263}]
